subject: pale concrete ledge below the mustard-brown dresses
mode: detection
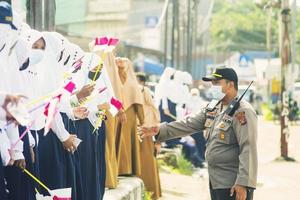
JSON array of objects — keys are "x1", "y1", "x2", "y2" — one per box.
[{"x1": 103, "y1": 177, "x2": 144, "y2": 200}]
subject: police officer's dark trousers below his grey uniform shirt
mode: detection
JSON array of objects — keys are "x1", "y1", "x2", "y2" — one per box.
[{"x1": 209, "y1": 184, "x2": 254, "y2": 200}]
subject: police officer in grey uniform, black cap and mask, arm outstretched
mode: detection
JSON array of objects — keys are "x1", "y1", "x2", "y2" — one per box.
[{"x1": 139, "y1": 67, "x2": 257, "y2": 200}]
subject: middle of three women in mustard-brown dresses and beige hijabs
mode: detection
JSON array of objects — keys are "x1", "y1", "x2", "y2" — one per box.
[{"x1": 116, "y1": 58, "x2": 144, "y2": 176}]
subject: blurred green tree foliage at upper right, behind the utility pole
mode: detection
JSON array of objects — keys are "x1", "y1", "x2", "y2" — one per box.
[{"x1": 210, "y1": 0, "x2": 278, "y2": 51}]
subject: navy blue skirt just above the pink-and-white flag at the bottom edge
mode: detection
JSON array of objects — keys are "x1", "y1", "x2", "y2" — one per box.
[{"x1": 38, "y1": 114, "x2": 81, "y2": 200}]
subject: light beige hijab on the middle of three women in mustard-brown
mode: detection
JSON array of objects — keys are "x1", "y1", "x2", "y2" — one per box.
[{"x1": 116, "y1": 58, "x2": 144, "y2": 110}]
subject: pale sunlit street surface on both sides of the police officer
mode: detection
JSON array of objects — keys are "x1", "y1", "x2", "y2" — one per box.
[{"x1": 161, "y1": 117, "x2": 300, "y2": 200}]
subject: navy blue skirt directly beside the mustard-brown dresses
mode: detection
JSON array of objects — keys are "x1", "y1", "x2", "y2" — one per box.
[{"x1": 75, "y1": 119, "x2": 105, "y2": 200}]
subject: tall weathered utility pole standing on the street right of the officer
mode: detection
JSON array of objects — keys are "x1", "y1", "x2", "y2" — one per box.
[{"x1": 280, "y1": 0, "x2": 290, "y2": 160}]
